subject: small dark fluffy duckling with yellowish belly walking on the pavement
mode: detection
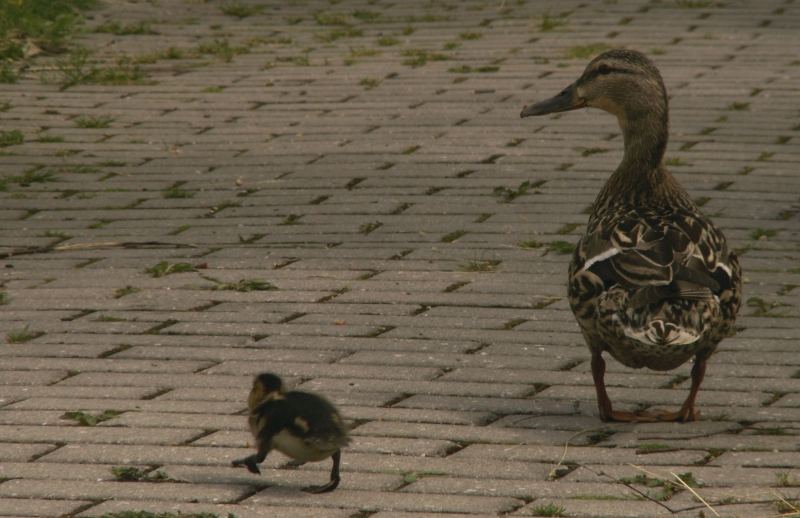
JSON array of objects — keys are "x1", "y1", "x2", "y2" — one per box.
[{"x1": 232, "y1": 372, "x2": 350, "y2": 493}]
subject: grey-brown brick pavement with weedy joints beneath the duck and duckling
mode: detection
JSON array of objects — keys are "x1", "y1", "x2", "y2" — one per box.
[{"x1": 0, "y1": 0, "x2": 800, "y2": 518}]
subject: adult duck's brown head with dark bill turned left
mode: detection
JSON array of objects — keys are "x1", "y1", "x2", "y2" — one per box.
[{"x1": 520, "y1": 49, "x2": 667, "y2": 128}]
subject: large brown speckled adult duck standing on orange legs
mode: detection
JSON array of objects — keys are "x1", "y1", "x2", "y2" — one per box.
[{"x1": 520, "y1": 50, "x2": 742, "y2": 422}]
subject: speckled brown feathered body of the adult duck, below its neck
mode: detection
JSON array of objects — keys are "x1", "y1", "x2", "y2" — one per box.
[{"x1": 569, "y1": 192, "x2": 741, "y2": 370}]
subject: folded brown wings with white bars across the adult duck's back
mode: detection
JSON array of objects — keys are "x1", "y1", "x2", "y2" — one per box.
[{"x1": 574, "y1": 213, "x2": 735, "y2": 307}]
